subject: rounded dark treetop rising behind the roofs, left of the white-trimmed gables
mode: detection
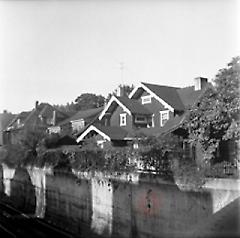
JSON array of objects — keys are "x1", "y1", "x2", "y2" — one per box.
[{"x1": 75, "y1": 93, "x2": 105, "y2": 110}]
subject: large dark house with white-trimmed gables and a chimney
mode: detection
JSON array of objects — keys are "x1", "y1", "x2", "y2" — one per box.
[{"x1": 77, "y1": 77, "x2": 210, "y2": 145}]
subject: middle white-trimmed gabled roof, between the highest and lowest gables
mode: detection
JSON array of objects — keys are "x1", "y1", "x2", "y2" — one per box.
[{"x1": 99, "y1": 95, "x2": 151, "y2": 120}]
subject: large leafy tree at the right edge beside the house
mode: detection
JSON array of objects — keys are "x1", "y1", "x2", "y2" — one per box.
[{"x1": 186, "y1": 57, "x2": 240, "y2": 160}]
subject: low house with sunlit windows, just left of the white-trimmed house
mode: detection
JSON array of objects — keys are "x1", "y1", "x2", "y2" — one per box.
[{"x1": 48, "y1": 107, "x2": 103, "y2": 135}]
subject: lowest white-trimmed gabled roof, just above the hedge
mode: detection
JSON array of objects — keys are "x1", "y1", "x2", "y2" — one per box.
[{"x1": 77, "y1": 125, "x2": 129, "y2": 143}]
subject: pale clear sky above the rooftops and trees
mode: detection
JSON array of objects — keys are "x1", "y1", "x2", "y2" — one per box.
[{"x1": 0, "y1": 0, "x2": 240, "y2": 113}]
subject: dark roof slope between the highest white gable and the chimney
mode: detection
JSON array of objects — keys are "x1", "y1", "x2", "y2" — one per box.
[{"x1": 142, "y1": 83, "x2": 184, "y2": 111}]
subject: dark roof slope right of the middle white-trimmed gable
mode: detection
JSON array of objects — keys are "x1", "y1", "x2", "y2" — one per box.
[{"x1": 116, "y1": 97, "x2": 152, "y2": 114}]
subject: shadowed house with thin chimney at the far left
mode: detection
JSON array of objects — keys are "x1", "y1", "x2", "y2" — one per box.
[{"x1": 4, "y1": 101, "x2": 68, "y2": 144}]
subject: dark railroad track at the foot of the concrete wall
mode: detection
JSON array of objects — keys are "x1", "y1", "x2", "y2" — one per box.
[{"x1": 0, "y1": 202, "x2": 74, "y2": 238}]
